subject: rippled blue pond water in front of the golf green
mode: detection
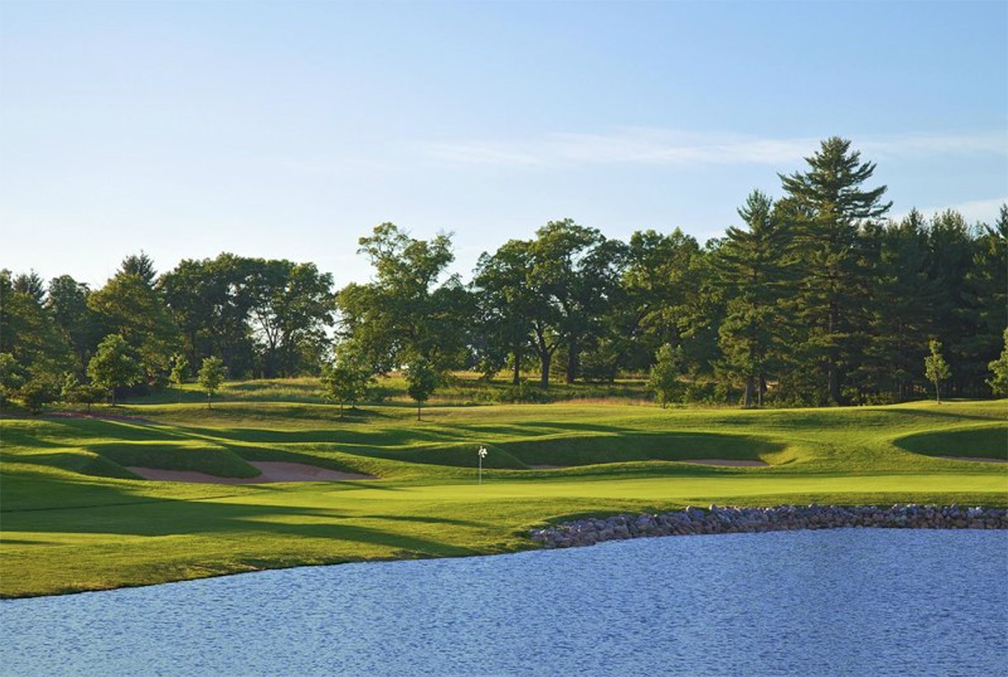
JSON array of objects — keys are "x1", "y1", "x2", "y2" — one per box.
[{"x1": 0, "y1": 529, "x2": 1008, "y2": 677}]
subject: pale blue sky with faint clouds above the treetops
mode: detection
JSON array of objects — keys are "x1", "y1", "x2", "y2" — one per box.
[{"x1": 0, "y1": 2, "x2": 1008, "y2": 285}]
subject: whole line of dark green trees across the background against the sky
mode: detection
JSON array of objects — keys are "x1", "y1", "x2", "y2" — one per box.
[{"x1": 0, "y1": 137, "x2": 1008, "y2": 406}]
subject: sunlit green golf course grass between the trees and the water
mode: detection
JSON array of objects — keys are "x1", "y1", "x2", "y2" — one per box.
[{"x1": 0, "y1": 384, "x2": 1008, "y2": 596}]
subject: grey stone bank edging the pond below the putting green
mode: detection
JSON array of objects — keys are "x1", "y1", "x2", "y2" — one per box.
[{"x1": 531, "y1": 504, "x2": 1008, "y2": 548}]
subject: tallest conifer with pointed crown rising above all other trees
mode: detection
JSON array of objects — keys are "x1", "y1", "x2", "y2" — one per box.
[{"x1": 780, "y1": 137, "x2": 892, "y2": 404}]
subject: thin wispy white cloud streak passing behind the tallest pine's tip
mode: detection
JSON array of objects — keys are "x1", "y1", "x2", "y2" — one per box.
[{"x1": 423, "y1": 127, "x2": 1008, "y2": 167}]
